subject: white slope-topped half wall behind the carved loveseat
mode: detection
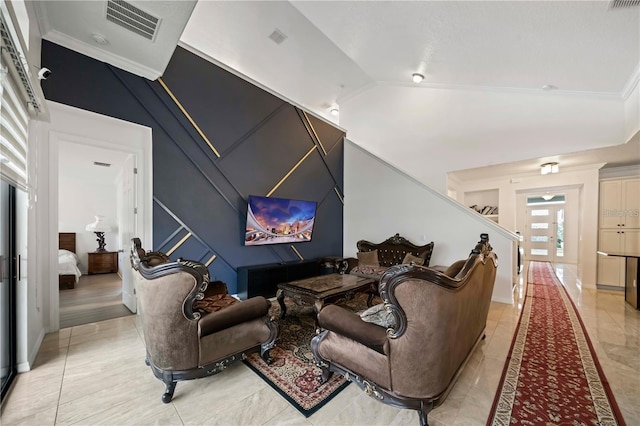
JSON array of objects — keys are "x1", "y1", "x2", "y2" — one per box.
[{"x1": 343, "y1": 140, "x2": 516, "y2": 303}]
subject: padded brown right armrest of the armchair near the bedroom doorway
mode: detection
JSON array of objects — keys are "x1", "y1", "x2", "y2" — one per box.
[{"x1": 199, "y1": 296, "x2": 271, "y2": 336}]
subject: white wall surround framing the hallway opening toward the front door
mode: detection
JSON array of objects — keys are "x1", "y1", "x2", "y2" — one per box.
[{"x1": 448, "y1": 163, "x2": 603, "y2": 288}]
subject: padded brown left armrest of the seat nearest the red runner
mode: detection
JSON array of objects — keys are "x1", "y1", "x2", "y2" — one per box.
[{"x1": 318, "y1": 305, "x2": 387, "y2": 354}]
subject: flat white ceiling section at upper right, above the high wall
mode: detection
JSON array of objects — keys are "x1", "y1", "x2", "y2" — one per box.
[{"x1": 293, "y1": 1, "x2": 640, "y2": 94}]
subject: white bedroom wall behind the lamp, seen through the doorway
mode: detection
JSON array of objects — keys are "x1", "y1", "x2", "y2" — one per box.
[{"x1": 58, "y1": 173, "x2": 120, "y2": 274}]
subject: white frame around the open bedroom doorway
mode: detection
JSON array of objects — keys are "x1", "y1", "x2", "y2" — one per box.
[{"x1": 42, "y1": 101, "x2": 153, "y2": 332}]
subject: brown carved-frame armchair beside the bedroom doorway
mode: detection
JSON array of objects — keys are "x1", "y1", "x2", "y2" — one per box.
[{"x1": 131, "y1": 238, "x2": 278, "y2": 403}]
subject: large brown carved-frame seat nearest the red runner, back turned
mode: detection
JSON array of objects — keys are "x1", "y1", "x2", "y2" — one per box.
[{"x1": 311, "y1": 234, "x2": 497, "y2": 425}]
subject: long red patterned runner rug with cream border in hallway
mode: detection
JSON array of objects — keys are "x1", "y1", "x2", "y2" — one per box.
[{"x1": 487, "y1": 262, "x2": 625, "y2": 425}]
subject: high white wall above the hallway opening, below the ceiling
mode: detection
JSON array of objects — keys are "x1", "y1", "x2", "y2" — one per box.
[{"x1": 340, "y1": 84, "x2": 633, "y2": 194}]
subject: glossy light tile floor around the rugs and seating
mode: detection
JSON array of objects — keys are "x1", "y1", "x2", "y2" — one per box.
[{"x1": 0, "y1": 265, "x2": 640, "y2": 426}]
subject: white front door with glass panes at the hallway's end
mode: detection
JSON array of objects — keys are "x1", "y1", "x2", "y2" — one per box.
[{"x1": 524, "y1": 194, "x2": 566, "y2": 263}]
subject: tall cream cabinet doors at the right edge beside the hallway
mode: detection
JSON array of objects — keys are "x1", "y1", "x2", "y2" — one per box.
[{"x1": 597, "y1": 178, "x2": 640, "y2": 288}]
